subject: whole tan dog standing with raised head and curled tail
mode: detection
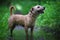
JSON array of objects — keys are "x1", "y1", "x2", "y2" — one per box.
[{"x1": 8, "y1": 5, "x2": 45, "y2": 40}]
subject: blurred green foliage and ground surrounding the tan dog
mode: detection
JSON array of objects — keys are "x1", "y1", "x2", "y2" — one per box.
[{"x1": 0, "y1": 0, "x2": 60, "y2": 40}]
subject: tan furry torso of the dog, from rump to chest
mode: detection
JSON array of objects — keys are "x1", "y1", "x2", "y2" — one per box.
[{"x1": 9, "y1": 14, "x2": 36, "y2": 27}]
